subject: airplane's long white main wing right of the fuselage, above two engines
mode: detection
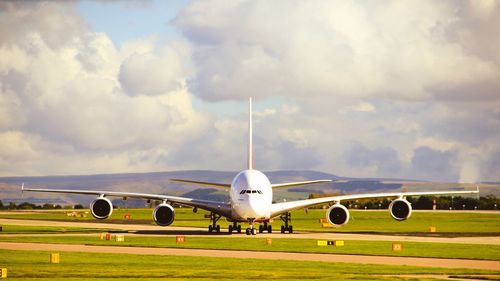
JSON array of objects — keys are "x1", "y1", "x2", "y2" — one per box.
[{"x1": 271, "y1": 188, "x2": 479, "y2": 217}]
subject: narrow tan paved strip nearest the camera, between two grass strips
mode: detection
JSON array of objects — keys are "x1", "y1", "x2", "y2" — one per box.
[{"x1": 0, "y1": 242, "x2": 500, "y2": 270}]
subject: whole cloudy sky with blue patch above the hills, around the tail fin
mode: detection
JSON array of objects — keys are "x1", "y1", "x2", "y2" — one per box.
[{"x1": 0, "y1": 0, "x2": 500, "y2": 182}]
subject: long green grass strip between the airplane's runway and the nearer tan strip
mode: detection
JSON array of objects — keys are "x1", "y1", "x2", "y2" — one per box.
[{"x1": 0, "y1": 235, "x2": 500, "y2": 260}]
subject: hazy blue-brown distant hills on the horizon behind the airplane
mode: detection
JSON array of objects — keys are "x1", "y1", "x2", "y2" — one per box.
[{"x1": 0, "y1": 170, "x2": 492, "y2": 206}]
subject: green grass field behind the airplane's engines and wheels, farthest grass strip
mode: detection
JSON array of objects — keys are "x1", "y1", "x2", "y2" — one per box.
[{"x1": 0, "y1": 208, "x2": 500, "y2": 235}]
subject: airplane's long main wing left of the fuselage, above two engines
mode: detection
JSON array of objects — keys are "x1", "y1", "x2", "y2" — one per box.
[{"x1": 22, "y1": 184, "x2": 231, "y2": 217}]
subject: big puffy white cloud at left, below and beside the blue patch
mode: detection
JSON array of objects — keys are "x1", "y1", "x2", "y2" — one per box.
[{"x1": 0, "y1": 2, "x2": 208, "y2": 175}]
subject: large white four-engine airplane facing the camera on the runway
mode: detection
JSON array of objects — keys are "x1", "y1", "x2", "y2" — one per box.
[{"x1": 21, "y1": 98, "x2": 479, "y2": 235}]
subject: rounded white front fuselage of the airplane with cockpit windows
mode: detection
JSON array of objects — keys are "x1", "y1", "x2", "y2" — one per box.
[{"x1": 229, "y1": 170, "x2": 273, "y2": 221}]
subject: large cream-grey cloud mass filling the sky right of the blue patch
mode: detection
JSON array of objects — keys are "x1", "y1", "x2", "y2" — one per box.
[{"x1": 174, "y1": 1, "x2": 500, "y2": 180}]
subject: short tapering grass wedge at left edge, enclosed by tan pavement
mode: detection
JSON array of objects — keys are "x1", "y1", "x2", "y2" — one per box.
[{"x1": 0, "y1": 224, "x2": 117, "y2": 234}]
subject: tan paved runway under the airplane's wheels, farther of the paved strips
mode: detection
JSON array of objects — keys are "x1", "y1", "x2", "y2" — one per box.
[{"x1": 0, "y1": 219, "x2": 500, "y2": 245}]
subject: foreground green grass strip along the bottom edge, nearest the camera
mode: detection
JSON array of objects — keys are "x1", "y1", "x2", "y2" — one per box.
[{"x1": 0, "y1": 250, "x2": 500, "y2": 281}]
